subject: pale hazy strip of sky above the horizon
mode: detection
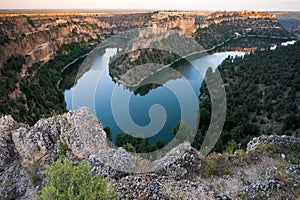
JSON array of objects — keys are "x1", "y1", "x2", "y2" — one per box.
[{"x1": 0, "y1": 0, "x2": 300, "y2": 11}]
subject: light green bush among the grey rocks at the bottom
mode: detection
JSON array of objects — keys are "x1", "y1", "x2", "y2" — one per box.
[{"x1": 36, "y1": 157, "x2": 117, "y2": 200}]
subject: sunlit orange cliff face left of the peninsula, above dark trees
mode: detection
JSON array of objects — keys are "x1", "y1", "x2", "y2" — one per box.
[{"x1": 0, "y1": 13, "x2": 148, "y2": 72}]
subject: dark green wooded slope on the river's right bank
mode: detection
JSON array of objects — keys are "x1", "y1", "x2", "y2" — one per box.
[{"x1": 192, "y1": 43, "x2": 300, "y2": 153}]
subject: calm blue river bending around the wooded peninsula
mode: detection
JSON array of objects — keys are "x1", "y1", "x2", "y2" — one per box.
[{"x1": 64, "y1": 48, "x2": 245, "y2": 145}]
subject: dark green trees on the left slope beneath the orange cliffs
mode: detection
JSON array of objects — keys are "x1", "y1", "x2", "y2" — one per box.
[{"x1": 0, "y1": 43, "x2": 92, "y2": 125}]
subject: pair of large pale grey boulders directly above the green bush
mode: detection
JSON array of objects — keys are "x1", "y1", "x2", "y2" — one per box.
[{"x1": 11, "y1": 108, "x2": 106, "y2": 164}]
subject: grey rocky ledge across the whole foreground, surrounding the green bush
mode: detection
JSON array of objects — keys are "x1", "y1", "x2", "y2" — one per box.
[{"x1": 0, "y1": 108, "x2": 300, "y2": 199}]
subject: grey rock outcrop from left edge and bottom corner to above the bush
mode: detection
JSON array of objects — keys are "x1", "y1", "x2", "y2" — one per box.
[{"x1": 0, "y1": 108, "x2": 106, "y2": 199}]
